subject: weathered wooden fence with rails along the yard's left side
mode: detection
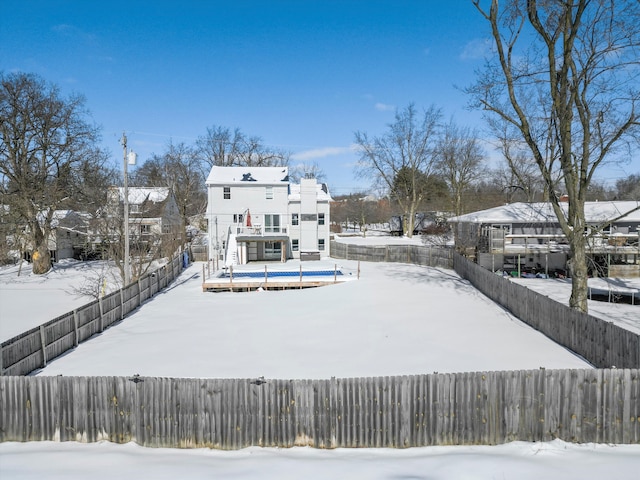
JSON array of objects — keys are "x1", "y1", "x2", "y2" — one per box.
[{"x1": 0, "y1": 254, "x2": 183, "y2": 375}]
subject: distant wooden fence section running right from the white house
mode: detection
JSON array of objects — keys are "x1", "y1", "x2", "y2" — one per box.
[{"x1": 330, "y1": 240, "x2": 453, "y2": 268}]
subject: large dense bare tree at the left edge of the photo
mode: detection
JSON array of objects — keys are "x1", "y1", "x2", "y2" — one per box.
[{"x1": 0, "y1": 73, "x2": 111, "y2": 274}]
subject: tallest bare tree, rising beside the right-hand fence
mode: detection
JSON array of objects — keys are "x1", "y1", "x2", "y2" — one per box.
[{"x1": 468, "y1": 0, "x2": 640, "y2": 312}]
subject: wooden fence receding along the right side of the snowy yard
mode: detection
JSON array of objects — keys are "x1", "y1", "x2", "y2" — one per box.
[{"x1": 454, "y1": 253, "x2": 640, "y2": 368}]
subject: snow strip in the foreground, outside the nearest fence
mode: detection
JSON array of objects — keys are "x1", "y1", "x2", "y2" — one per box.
[{"x1": 0, "y1": 440, "x2": 640, "y2": 480}]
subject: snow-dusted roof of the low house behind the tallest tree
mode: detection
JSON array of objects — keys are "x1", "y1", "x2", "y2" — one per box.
[{"x1": 449, "y1": 201, "x2": 640, "y2": 223}]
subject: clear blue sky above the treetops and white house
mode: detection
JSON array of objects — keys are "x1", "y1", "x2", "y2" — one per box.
[{"x1": 0, "y1": 0, "x2": 632, "y2": 195}]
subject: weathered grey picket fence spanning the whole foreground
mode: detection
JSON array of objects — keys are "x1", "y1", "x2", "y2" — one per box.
[{"x1": 0, "y1": 369, "x2": 640, "y2": 449}]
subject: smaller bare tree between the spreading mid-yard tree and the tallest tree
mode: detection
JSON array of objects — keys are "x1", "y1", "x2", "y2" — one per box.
[{"x1": 436, "y1": 121, "x2": 485, "y2": 215}]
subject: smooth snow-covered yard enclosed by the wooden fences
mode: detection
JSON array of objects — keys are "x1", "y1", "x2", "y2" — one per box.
[{"x1": 26, "y1": 260, "x2": 588, "y2": 379}]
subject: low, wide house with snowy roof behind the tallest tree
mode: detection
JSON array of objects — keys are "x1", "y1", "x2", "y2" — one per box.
[{"x1": 449, "y1": 201, "x2": 640, "y2": 276}]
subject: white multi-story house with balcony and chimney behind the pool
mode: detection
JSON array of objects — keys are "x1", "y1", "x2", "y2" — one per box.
[{"x1": 206, "y1": 167, "x2": 331, "y2": 265}]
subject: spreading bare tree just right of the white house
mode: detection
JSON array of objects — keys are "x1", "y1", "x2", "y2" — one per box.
[{"x1": 355, "y1": 104, "x2": 441, "y2": 237}]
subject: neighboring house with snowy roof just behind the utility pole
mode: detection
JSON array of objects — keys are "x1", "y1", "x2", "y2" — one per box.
[{"x1": 107, "y1": 187, "x2": 183, "y2": 251}]
